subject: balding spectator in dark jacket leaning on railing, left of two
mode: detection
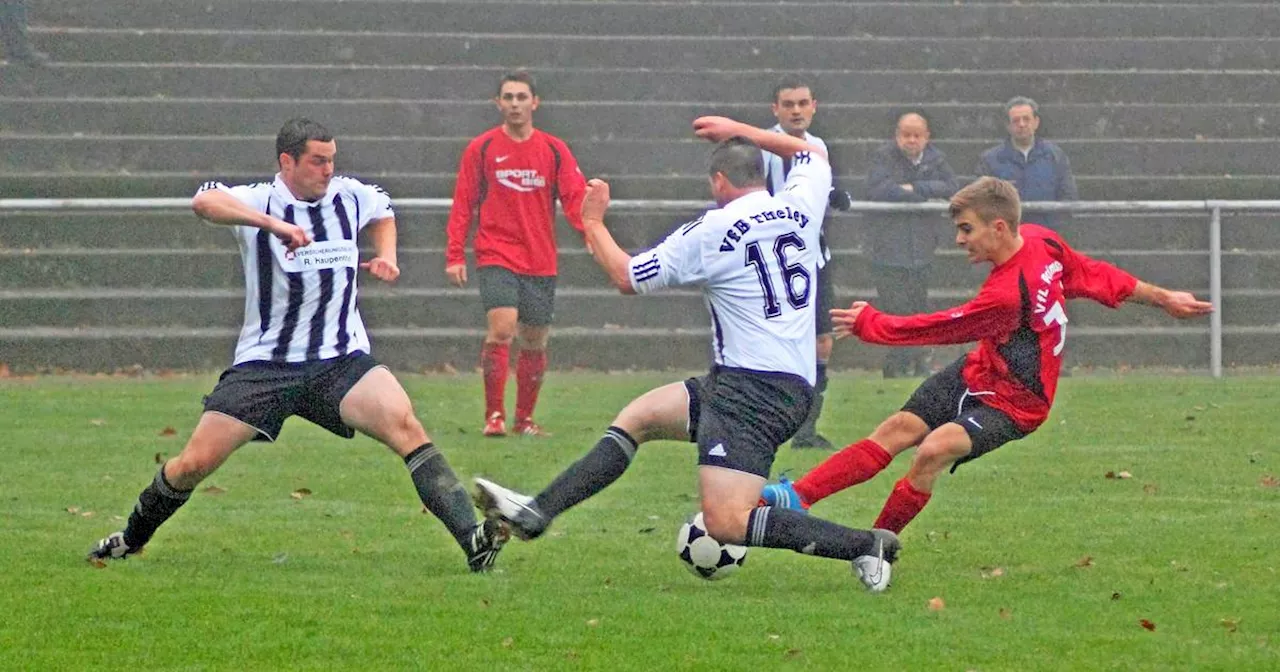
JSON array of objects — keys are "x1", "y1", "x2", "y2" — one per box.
[{"x1": 867, "y1": 113, "x2": 960, "y2": 378}]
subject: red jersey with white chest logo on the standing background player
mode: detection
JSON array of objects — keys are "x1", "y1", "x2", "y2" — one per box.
[{"x1": 444, "y1": 125, "x2": 586, "y2": 275}]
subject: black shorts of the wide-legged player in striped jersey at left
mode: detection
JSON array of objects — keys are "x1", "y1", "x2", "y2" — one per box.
[{"x1": 205, "y1": 352, "x2": 381, "y2": 442}]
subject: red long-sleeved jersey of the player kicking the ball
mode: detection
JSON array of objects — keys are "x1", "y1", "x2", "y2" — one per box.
[{"x1": 854, "y1": 224, "x2": 1138, "y2": 431}]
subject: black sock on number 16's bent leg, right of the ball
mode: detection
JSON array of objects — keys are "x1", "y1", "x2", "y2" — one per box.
[{"x1": 744, "y1": 507, "x2": 876, "y2": 561}]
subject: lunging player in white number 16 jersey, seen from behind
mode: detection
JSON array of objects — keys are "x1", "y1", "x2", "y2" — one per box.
[{"x1": 476, "y1": 116, "x2": 899, "y2": 590}]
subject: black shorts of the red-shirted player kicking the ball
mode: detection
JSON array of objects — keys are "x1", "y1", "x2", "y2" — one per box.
[{"x1": 902, "y1": 355, "x2": 1028, "y2": 471}]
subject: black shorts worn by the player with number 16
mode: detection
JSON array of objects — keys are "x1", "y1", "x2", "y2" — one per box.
[{"x1": 685, "y1": 366, "x2": 813, "y2": 479}]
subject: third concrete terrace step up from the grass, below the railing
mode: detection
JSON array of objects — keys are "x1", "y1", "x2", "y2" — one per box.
[{"x1": 0, "y1": 248, "x2": 1259, "y2": 289}]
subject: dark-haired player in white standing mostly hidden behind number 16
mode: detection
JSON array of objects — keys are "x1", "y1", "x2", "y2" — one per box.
[{"x1": 762, "y1": 76, "x2": 849, "y2": 451}]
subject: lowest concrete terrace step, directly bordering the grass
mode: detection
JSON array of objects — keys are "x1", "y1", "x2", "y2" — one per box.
[{"x1": 0, "y1": 324, "x2": 1264, "y2": 374}]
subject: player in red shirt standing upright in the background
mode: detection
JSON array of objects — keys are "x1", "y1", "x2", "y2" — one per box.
[{"x1": 444, "y1": 72, "x2": 586, "y2": 436}]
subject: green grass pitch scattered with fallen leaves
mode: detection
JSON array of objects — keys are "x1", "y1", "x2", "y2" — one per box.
[{"x1": 0, "y1": 374, "x2": 1280, "y2": 671}]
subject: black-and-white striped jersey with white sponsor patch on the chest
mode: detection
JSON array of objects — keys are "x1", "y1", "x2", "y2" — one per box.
[{"x1": 197, "y1": 174, "x2": 396, "y2": 364}]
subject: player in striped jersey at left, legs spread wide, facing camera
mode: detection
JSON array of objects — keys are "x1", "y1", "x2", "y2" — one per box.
[{"x1": 88, "y1": 118, "x2": 508, "y2": 572}]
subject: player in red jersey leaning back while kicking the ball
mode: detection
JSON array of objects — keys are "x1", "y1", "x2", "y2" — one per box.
[{"x1": 762, "y1": 177, "x2": 1213, "y2": 532}]
